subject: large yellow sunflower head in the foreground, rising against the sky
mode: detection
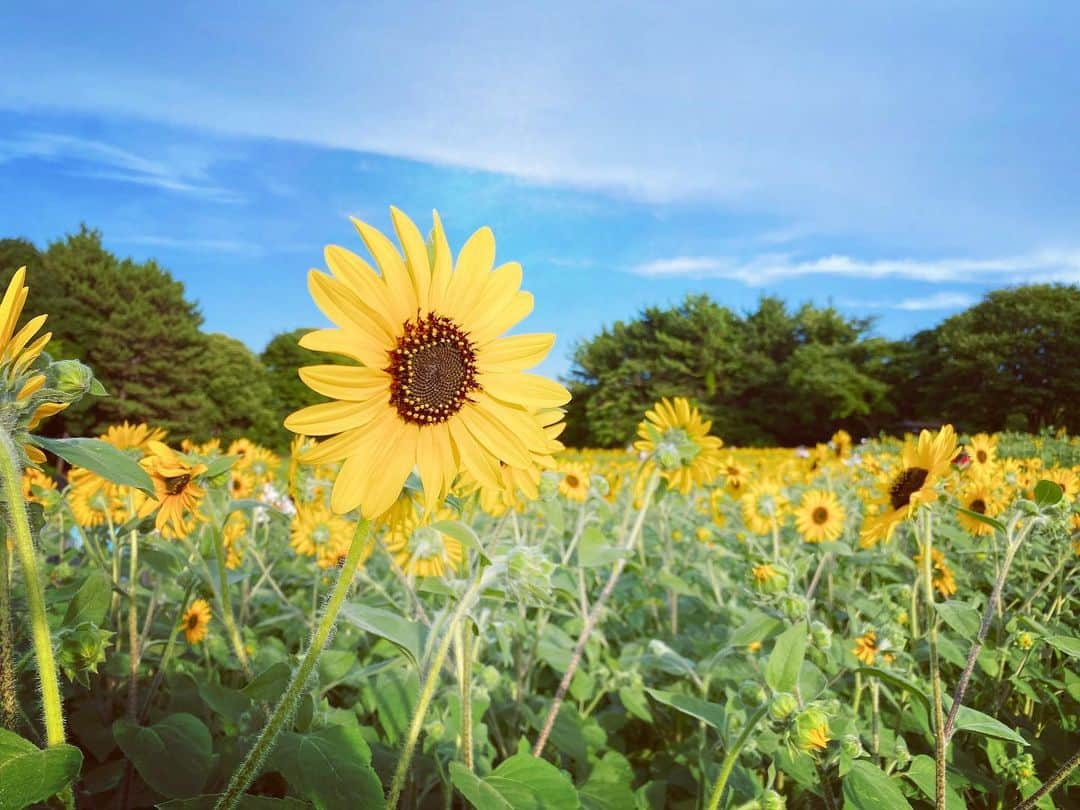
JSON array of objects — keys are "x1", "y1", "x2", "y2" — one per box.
[{"x1": 285, "y1": 208, "x2": 570, "y2": 517}]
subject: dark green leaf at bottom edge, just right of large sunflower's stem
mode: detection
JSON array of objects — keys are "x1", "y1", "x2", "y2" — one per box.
[{"x1": 268, "y1": 724, "x2": 386, "y2": 810}]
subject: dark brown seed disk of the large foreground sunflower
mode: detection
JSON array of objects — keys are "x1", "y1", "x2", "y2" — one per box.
[{"x1": 386, "y1": 314, "x2": 480, "y2": 424}]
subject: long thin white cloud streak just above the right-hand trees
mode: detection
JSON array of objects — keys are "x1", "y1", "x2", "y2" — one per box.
[{"x1": 630, "y1": 251, "x2": 1080, "y2": 287}]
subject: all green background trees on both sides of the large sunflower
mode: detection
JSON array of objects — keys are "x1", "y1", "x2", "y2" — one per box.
[{"x1": 0, "y1": 226, "x2": 1080, "y2": 449}]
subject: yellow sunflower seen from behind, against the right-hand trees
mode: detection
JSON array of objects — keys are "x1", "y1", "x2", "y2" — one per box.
[{"x1": 634, "y1": 396, "x2": 724, "y2": 495}]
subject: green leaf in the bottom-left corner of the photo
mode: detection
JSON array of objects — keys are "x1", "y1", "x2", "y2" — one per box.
[{"x1": 0, "y1": 728, "x2": 82, "y2": 810}]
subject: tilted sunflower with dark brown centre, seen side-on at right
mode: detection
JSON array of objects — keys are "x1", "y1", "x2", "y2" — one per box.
[{"x1": 859, "y1": 424, "x2": 956, "y2": 549}]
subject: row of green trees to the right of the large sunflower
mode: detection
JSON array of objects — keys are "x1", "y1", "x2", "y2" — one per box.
[{"x1": 567, "y1": 284, "x2": 1080, "y2": 446}]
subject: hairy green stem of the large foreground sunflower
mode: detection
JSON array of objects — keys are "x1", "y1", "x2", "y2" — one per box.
[{"x1": 215, "y1": 518, "x2": 368, "y2": 810}]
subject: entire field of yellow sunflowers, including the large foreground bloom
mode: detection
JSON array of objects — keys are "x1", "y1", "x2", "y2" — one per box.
[{"x1": 0, "y1": 210, "x2": 1080, "y2": 810}]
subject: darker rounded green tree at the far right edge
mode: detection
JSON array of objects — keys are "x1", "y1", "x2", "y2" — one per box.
[{"x1": 909, "y1": 284, "x2": 1080, "y2": 432}]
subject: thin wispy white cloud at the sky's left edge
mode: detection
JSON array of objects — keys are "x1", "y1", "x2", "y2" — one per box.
[{"x1": 0, "y1": 132, "x2": 241, "y2": 202}]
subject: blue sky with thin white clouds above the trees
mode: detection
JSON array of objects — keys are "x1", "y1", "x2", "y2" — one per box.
[{"x1": 0, "y1": 0, "x2": 1080, "y2": 374}]
